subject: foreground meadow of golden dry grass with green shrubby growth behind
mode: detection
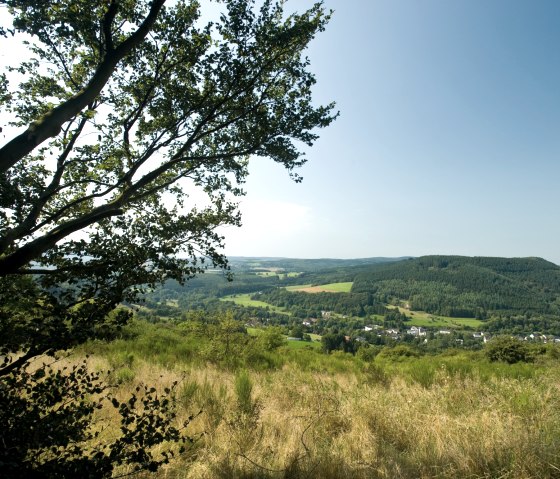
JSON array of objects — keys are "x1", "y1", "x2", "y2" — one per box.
[{"x1": 73, "y1": 321, "x2": 560, "y2": 479}]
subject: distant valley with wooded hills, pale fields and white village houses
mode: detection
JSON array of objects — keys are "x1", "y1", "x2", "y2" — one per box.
[{"x1": 138, "y1": 256, "x2": 560, "y2": 348}]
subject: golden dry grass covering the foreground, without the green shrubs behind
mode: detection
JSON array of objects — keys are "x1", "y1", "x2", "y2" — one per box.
[{"x1": 77, "y1": 352, "x2": 560, "y2": 479}]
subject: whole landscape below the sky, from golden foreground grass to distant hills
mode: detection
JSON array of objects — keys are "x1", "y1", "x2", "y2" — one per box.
[{"x1": 65, "y1": 253, "x2": 560, "y2": 479}]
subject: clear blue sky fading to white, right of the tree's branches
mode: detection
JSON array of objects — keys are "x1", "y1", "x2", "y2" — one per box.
[{"x1": 220, "y1": 0, "x2": 560, "y2": 264}]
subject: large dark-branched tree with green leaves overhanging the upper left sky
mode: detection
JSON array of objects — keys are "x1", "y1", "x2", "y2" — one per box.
[{"x1": 0, "y1": 0, "x2": 336, "y2": 476}]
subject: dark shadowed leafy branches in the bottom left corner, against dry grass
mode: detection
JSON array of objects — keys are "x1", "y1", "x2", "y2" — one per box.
[{"x1": 0, "y1": 361, "x2": 187, "y2": 478}]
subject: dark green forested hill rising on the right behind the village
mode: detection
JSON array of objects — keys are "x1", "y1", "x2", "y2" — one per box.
[{"x1": 352, "y1": 256, "x2": 560, "y2": 318}]
